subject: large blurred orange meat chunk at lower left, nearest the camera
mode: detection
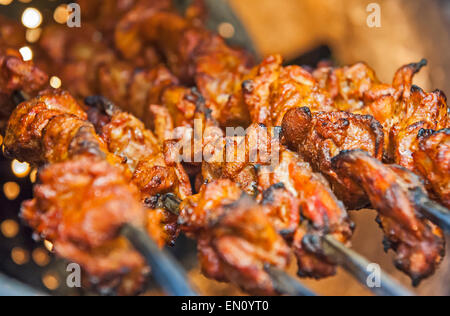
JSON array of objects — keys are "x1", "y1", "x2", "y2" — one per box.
[{"x1": 21, "y1": 157, "x2": 146, "y2": 294}]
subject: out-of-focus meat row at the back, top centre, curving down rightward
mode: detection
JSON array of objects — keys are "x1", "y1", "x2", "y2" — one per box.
[{"x1": 115, "y1": 3, "x2": 252, "y2": 127}]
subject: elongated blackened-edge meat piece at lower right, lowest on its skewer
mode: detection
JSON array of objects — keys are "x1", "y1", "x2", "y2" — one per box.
[{"x1": 332, "y1": 150, "x2": 445, "y2": 285}]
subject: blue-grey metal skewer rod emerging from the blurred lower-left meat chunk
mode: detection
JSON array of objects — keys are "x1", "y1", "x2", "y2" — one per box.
[{"x1": 121, "y1": 224, "x2": 197, "y2": 296}]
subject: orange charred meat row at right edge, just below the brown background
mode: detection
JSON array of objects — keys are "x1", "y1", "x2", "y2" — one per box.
[{"x1": 314, "y1": 61, "x2": 450, "y2": 206}]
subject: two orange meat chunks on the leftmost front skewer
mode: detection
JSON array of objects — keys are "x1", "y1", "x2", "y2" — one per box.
[{"x1": 4, "y1": 81, "x2": 146, "y2": 294}]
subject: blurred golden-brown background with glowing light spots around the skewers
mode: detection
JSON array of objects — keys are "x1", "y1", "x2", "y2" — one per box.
[{"x1": 0, "y1": 0, "x2": 450, "y2": 295}]
